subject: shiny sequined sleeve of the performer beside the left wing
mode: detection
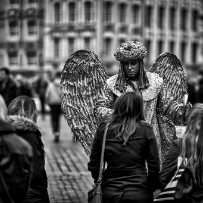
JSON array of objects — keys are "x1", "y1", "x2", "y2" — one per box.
[{"x1": 95, "y1": 85, "x2": 115, "y2": 122}]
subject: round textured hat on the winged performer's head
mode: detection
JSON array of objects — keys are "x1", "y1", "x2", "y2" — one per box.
[{"x1": 114, "y1": 41, "x2": 147, "y2": 62}]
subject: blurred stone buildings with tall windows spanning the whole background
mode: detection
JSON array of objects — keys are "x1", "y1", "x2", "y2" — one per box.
[{"x1": 0, "y1": 0, "x2": 203, "y2": 76}]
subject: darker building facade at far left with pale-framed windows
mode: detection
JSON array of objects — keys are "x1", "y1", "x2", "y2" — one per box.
[{"x1": 0, "y1": 0, "x2": 44, "y2": 75}]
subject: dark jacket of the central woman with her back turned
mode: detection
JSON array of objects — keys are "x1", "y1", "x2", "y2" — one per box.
[{"x1": 88, "y1": 121, "x2": 159, "y2": 202}]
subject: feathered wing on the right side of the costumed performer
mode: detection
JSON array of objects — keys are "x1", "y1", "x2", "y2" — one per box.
[{"x1": 150, "y1": 52, "x2": 191, "y2": 139}]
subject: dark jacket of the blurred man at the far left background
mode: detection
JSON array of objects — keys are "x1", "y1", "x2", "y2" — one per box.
[{"x1": 0, "y1": 78, "x2": 19, "y2": 106}]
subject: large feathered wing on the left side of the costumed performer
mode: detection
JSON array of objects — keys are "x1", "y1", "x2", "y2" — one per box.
[{"x1": 61, "y1": 50, "x2": 108, "y2": 155}]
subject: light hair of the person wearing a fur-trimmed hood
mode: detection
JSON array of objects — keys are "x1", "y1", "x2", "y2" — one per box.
[{"x1": 8, "y1": 96, "x2": 37, "y2": 122}]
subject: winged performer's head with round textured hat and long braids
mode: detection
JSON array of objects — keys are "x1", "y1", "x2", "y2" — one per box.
[{"x1": 114, "y1": 41, "x2": 149, "y2": 92}]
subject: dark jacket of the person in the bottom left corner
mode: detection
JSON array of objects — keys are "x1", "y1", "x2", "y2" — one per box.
[{"x1": 0, "y1": 120, "x2": 32, "y2": 203}]
